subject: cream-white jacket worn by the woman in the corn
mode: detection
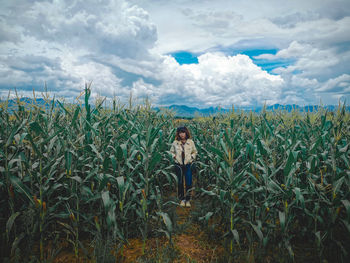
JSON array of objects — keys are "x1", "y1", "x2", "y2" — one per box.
[{"x1": 170, "y1": 139, "x2": 198, "y2": 164}]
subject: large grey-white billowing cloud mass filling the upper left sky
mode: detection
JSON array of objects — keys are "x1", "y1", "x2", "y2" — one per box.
[{"x1": 0, "y1": 0, "x2": 157, "y2": 97}]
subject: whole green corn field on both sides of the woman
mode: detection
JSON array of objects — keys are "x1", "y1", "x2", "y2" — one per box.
[{"x1": 0, "y1": 87, "x2": 350, "y2": 262}]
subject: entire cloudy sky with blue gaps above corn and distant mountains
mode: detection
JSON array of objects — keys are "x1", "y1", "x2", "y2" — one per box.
[{"x1": 0, "y1": 0, "x2": 350, "y2": 108}]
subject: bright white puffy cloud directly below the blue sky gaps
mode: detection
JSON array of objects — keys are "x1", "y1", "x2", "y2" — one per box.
[{"x1": 153, "y1": 53, "x2": 283, "y2": 107}]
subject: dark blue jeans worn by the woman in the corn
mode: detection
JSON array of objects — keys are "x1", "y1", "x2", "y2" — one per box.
[{"x1": 175, "y1": 164, "x2": 192, "y2": 201}]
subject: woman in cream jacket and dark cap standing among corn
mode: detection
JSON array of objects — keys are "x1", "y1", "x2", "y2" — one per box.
[{"x1": 170, "y1": 127, "x2": 198, "y2": 207}]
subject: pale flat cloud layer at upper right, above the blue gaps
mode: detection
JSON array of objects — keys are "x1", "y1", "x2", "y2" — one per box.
[{"x1": 133, "y1": 0, "x2": 350, "y2": 54}]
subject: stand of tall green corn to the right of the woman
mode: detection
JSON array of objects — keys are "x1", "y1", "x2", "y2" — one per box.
[{"x1": 191, "y1": 106, "x2": 350, "y2": 261}]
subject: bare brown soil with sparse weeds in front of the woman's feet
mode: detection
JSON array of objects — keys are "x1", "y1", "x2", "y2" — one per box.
[{"x1": 53, "y1": 202, "x2": 224, "y2": 263}]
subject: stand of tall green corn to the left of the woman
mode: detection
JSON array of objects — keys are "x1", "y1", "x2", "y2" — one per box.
[{"x1": 0, "y1": 85, "x2": 173, "y2": 262}]
